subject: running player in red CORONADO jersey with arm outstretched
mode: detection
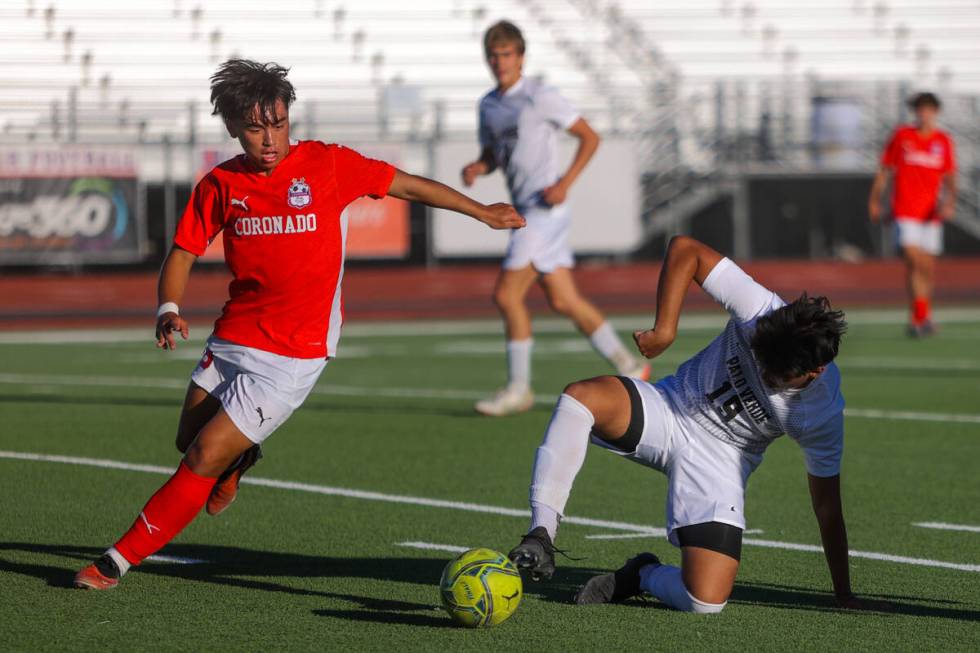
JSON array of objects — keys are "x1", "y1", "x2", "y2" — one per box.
[{"x1": 74, "y1": 59, "x2": 524, "y2": 589}]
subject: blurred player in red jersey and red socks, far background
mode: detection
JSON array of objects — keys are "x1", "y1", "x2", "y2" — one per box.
[{"x1": 868, "y1": 93, "x2": 956, "y2": 337}]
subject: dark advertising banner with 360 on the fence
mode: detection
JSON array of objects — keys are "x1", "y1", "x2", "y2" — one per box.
[{"x1": 0, "y1": 146, "x2": 146, "y2": 265}]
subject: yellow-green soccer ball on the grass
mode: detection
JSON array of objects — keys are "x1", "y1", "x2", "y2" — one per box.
[{"x1": 439, "y1": 549, "x2": 523, "y2": 628}]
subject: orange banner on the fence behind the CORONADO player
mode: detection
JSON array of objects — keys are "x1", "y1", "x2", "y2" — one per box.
[{"x1": 193, "y1": 144, "x2": 411, "y2": 261}]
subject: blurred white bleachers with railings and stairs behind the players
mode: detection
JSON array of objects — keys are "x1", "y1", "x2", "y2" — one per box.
[{"x1": 0, "y1": 0, "x2": 980, "y2": 258}]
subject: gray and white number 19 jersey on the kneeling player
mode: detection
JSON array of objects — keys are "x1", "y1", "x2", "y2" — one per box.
[{"x1": 657, "y1": 258, "x2": 844, "y2": 476}]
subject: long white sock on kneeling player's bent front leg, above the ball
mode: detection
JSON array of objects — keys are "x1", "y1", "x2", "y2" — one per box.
[{"x1": 531, "y1": 394, "x2": 595, "y2": 541}]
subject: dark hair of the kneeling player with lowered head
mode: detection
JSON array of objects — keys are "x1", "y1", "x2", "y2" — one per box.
[{"x1": 752, "y1": 293, "x2": 847, "y2": 381}]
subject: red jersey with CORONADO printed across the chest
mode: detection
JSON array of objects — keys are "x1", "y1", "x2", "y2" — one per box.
[{"x1": 174, "y1": 141, "x2": 395, "y2": 358}]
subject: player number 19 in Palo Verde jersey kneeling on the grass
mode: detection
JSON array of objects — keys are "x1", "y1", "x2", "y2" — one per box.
[{"x1": 510, "y1": 237, "x2": 876, "y2": 613}]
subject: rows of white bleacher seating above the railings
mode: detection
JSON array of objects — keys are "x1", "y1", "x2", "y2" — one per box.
[{"x1": 0, "y1": 0, "x2": 980, "y2": 145}]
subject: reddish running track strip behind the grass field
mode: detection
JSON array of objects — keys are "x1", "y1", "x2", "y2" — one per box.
[{"x1": 0, "y1": 258, "x2": 980, "y2": 330}]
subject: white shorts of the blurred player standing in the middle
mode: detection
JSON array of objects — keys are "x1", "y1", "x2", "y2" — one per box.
[{"x1": 503, "y1": 204, "x2": 575, "y2": 274}]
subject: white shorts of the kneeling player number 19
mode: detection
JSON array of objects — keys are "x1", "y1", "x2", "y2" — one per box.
[{"x1": 592, "y1": 379, "x2": 761, "y2": 546}]
